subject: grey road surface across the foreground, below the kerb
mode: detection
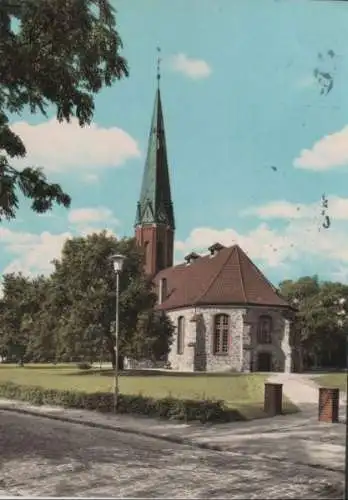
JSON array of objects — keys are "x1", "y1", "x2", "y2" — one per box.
[{"x1": 0, "y1": 411, "x2": 343, "y2": 499}]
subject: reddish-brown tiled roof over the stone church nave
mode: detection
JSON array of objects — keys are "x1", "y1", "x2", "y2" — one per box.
[{"x1": 154, "y1": 245, "x2": 290, "y2": 310}]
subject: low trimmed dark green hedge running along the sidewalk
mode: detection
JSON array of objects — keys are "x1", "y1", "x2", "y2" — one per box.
[{"x1": 0, "y1": 382, "x2": 242, "y2": 423}]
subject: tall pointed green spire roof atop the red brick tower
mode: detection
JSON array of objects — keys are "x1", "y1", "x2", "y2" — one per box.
[{"x1": 135, "y1": 84, "x2": 175, "y2": 230}]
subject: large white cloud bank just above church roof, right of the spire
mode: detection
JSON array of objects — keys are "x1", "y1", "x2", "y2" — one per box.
[{"x1": 209, "y1": 196, "x2": 348, "y2": 281}]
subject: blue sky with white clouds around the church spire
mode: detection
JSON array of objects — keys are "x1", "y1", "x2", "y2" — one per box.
[{"x1": 0, "y1": 0, "x2": 348, "y2": 283}]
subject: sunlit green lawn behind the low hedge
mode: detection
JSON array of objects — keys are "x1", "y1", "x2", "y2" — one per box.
[{"x1": 0, "y1": 365, "x2": 296, "y2": 419}]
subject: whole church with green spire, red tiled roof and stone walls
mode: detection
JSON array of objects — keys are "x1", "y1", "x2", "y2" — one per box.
[{"x1": 135, "y1": 75, "x2": 293, "y2": 372}]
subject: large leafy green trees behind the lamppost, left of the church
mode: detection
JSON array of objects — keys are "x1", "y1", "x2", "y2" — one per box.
[{"x1": 0, "y1": 232, "x2": 173, "y2": 366}]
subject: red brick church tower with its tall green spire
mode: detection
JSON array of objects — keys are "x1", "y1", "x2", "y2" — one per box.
[{"x1": 135, "y1": 52, "x2": 175, "y2": 277}]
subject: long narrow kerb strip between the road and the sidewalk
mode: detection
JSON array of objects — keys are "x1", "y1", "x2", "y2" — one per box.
[{"x1": 0, "y1": 404, "x2": 344, "y2": 473}]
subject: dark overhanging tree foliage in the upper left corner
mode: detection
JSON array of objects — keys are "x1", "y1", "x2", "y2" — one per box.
[{"x1": 0, "y1": 0, "x2": 128, "y2": 221}]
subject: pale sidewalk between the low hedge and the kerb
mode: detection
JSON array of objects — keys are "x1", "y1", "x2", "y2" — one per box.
[{"x1": 0, "y1": 388, "x2": 345, "y2": 472}]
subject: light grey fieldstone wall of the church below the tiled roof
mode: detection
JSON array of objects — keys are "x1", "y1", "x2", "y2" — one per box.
[{"x1": 168, "y1": 307, "x2": 292, "y2": 372}]
